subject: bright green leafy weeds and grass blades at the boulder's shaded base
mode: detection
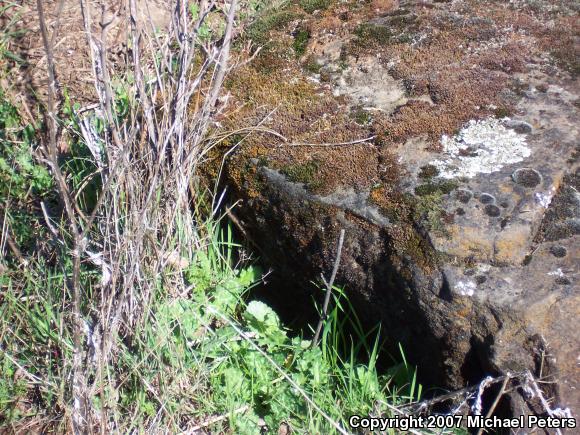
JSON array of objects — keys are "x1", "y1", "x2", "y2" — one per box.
[{"x1": 202, "y1": 282, "x2": 420, "y2": 433}]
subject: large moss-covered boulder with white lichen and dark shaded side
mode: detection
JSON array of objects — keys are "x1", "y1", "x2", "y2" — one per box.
[{"x1": 223, "y1": 0, "x2": 580, "y2": 416}]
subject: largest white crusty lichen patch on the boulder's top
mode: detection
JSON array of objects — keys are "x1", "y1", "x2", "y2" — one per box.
[{"x1": 432, "y1": 118, "x2": 531, "y2": 178}]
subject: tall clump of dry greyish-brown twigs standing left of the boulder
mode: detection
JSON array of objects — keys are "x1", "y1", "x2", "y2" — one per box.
[{"x1": 37, "y1": 0, "x2": 237, "y2": 433}]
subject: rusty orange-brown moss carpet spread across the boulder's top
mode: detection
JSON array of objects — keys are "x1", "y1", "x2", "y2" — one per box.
[{"x1": 202, "y1": 0, "x2": 579, "y2": 276}]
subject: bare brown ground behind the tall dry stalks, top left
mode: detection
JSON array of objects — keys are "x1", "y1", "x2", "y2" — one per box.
[{"x1": 0, "y1": 0, "x2": 171, "y2": 109}]
